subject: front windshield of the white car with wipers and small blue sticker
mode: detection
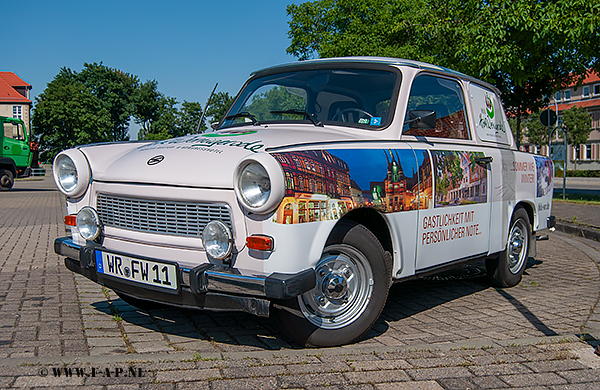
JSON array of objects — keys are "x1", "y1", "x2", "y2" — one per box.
[{"x1": 221, "y1": 69, "x2": 398, "y2": 129}]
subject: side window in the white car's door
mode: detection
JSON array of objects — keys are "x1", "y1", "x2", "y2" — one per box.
[{"x1": 403, "y1": 75, "x2": 470, "y2": 140}]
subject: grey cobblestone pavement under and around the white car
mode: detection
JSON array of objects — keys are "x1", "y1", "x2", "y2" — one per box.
[{"x1": 0, "y1": 178, "x2": 600, "y2": 389}]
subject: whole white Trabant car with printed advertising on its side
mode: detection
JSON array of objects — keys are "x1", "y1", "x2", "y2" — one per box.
[{"x1": 54, "y1": 57, "x2": 554, "y2": 346}]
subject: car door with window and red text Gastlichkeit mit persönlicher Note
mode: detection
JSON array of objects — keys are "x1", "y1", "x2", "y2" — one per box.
[{"x1": 402, "y1": 73, "x2": 491, "y2": 273}]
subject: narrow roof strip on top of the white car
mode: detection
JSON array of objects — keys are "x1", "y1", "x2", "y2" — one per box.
[{"x1": 250, "y1": 56, "x2": 500, "y2": 95}]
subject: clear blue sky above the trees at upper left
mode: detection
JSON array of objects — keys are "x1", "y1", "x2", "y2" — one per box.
[{"x1": 0, "y1": 0, "x2": 302, "y2": 139}]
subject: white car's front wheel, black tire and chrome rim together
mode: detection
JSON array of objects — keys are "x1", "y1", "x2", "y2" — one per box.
[{"x1": 274, "y1": 222, "x2": 390, "y2": 347}]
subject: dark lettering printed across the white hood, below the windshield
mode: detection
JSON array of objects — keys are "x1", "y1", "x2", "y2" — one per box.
[{"x1": 139, "y1": 135, "x2": 265, "y2": 153}]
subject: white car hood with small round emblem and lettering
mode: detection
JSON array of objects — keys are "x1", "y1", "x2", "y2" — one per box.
[{"x1": 81, "y1": 125, "x2": 365, "y2": 188}]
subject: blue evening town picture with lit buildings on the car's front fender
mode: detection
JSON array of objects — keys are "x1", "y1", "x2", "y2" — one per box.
[{"x1": 272, "y1": 149, "x2": 433, "y2": 224}]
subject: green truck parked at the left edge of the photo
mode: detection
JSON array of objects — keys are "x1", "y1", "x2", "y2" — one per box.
[{"x1": 0, "y1": 116, "x2": 33, "y2": 191}]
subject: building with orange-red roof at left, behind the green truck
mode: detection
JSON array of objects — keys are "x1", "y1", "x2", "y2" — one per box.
[{"x1": 0, "y1": 72, "x2": 32, "y2": 128}]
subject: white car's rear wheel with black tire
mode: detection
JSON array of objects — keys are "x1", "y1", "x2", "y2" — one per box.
[{"x1": 485, "y1": 207, "x2": 532, "y2": 287}]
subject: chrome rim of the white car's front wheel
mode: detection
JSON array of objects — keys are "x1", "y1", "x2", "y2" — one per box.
[{"x1": 298, "y1": 245, "x2": 374, "y2": 329}]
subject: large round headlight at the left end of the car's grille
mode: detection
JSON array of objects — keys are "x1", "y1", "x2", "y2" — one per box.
[{"x1": 52, "y1": 149, "x2": 91, "y2": 198}]
